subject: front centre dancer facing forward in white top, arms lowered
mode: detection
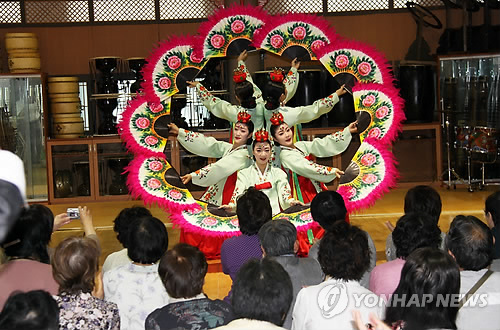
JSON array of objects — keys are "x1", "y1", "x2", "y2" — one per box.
[{"x1": 223, "y1": 130, "x2": 304, "y2": 216}]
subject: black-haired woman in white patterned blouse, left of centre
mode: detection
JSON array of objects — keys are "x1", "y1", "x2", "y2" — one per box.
[{"x1": 103, "y1": 217, "x2": 170, "y2": 330}]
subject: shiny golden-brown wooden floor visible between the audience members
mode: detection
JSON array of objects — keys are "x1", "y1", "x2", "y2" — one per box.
[{"x1": 49, "y1": 184, "x2": 499, "y2": 299}]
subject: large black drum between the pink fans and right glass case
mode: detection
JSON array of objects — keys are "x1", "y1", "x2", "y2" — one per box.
[{"x1": 398, "y1": 65, "x2": 436, "y2": 123}]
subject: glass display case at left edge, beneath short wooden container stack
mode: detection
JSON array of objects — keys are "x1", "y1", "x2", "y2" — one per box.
[{"x1": 0, "y1": 74, "x2": 48, "y2": 201}]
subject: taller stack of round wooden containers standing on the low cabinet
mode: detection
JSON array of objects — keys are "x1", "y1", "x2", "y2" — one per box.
[{"x1": 48, "y1": 77, "x2": 83, "y2": 139}]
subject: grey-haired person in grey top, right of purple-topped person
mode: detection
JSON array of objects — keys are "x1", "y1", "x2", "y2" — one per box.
[{"x1": 259, "y1": 220, "x2": 323, "y2": 329}]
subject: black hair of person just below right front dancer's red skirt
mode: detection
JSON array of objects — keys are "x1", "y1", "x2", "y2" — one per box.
[{"x1": 311, "y1": 190, "x2": 347, "y2": 231}]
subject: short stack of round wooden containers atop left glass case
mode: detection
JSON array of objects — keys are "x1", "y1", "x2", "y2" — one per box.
[{"x1": 5, "y1": 33, "x2": 40, "y2": 73}]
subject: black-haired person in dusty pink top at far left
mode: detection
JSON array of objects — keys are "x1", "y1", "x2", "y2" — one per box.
[{"x1": 0, "y1": 204, "x2": 59, "y2": 308}]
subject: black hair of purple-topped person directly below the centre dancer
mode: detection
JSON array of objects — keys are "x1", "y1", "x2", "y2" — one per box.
[{"x1": 236, "y1": 187, "x2": 273, "y2": 235}]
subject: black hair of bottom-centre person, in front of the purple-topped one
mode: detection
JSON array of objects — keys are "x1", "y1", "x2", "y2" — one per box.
[{"x1": 231, "y1": 258, "x2": 293, "y2": 326}]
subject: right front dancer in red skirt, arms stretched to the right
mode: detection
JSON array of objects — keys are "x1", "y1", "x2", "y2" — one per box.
[{"x1": 270, "y1": 113, "x2": 358, "y2": 203}]
